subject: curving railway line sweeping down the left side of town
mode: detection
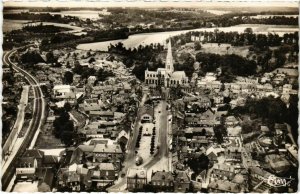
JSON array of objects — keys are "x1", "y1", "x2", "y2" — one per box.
[{"x1": 1, "y1": 50, "x2": 45, "y2": 191}]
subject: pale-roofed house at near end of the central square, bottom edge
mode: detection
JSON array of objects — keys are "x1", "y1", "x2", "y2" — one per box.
[{"x1": 126, "y1": 168, "x2": 147, "y2": 192}]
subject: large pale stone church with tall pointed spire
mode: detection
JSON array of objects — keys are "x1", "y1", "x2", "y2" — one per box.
[{"x1": 145, "y1": 41, "x2": 188, "y2": 88}]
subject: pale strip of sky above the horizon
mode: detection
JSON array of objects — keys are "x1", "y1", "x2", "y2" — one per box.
[{"x1": 3, "y1": 0, "x2": 299, "y2": 8}]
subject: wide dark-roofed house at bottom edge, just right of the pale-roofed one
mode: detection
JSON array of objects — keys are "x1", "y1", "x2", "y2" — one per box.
[{"x1": 151, "y1": 171, "x2": 174, "y2": 192}]
